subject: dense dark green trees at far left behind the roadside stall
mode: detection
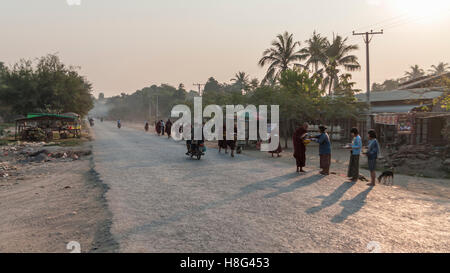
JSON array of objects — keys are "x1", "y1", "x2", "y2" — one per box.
[{"x1": 0, "y1": 54, "x2": 94, "y2": 120}]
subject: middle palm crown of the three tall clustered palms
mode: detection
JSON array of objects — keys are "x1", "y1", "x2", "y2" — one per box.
[{"x1": 301, "y1": 31, "x2": 330, "y2": 73}]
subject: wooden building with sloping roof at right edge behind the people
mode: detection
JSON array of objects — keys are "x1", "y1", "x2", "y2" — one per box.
[{"x1": 356, "y1": 73, "x2": 450, "y2": 146}]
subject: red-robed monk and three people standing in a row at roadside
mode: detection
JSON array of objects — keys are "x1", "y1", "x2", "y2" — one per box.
[{"x1": 293, "y1": 123, "x2": 380, "y2": 186}]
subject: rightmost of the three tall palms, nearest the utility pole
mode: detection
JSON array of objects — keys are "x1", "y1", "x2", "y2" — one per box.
[{"x1": 323, "y1": 35, "x2": 361, "y2": 96}]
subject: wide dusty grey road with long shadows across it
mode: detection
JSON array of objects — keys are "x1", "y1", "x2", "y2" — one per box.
[{"x1": 94, "y1": 122, "x2": 450, "y2": 253}]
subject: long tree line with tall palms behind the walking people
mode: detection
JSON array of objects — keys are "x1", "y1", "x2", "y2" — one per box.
[{"x1": 99, "y1": 32, "x2": 365, "y2": 147}]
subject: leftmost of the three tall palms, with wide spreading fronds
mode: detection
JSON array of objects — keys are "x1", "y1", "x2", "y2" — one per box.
[{"x1": 259, "y1": 31, "x2": 307, "y2": 84}]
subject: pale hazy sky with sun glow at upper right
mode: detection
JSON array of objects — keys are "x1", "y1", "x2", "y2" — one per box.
[{"x1": 0, "y1": 0, "x2": 450, "y2": 96}]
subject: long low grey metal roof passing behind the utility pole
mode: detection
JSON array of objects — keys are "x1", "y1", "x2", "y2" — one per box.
[{"x1": 356, "y1": 88, "x2": 444, "y2": 102}]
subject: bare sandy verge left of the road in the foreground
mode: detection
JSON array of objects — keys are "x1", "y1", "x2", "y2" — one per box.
[{"x1": 0, "y1": 137, "x2": 116, "y2": 253}]
